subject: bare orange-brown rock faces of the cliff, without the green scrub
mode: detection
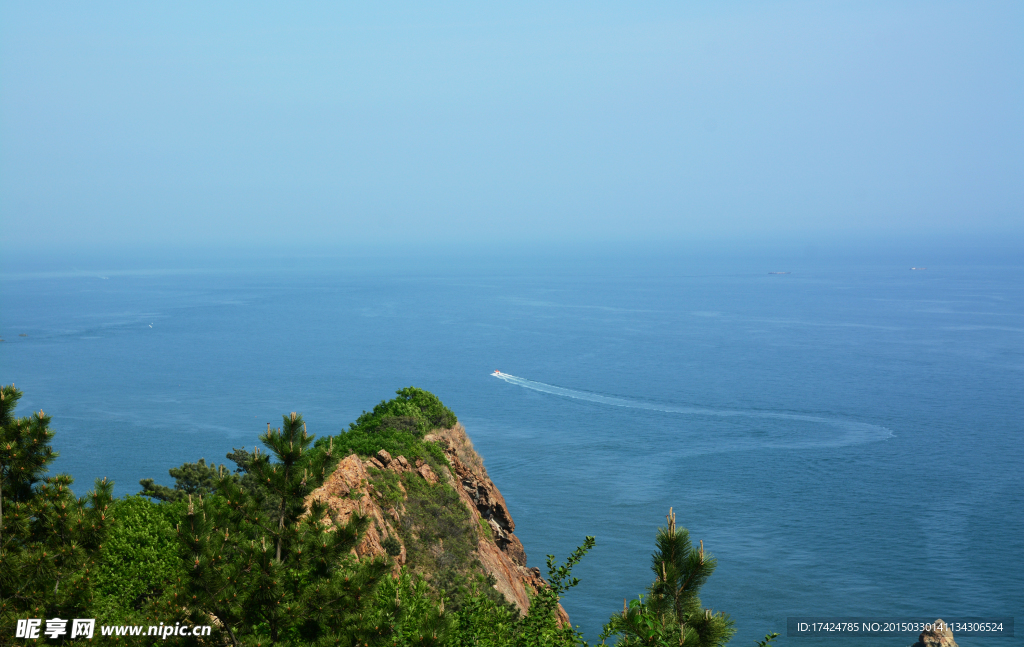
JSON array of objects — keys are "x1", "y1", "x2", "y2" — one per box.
[{"x1": 306, "y1": 425, "x2": 568, "y2": 623}]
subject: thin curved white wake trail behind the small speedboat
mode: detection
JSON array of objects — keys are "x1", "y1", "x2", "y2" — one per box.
[{"x1": 490, "y1": 373, "x2": 893, "y2": 446}]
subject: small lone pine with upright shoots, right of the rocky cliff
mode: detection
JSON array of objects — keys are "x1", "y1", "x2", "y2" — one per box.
[{"x1": 601, "y1": 508, "x2": 735, "y2": 647}]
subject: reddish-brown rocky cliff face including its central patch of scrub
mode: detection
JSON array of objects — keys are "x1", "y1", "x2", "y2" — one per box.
[{"x1": 307, "y1": 424, "x2": 568, "y2": 622}]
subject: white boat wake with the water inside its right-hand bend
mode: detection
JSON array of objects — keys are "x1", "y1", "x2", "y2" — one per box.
[{"x1": 490, "y1": 371, "x2": 893, "y2": 448}]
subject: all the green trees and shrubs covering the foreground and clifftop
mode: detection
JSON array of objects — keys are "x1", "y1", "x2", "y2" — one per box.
[{"x1": 0, "y1": 387, "x2": 777, "y2": 647}]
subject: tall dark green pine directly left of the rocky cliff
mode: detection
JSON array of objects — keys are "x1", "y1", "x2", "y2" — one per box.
[{"x1": 168, "y1": 414, "x2": 389, "y2": 645}]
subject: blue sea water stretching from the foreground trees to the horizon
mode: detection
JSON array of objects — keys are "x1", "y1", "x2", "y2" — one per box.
[{"x1": 0, "y1": 248, "x2": 1024, "y2": 647}]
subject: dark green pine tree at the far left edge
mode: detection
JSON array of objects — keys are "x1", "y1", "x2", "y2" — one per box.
[{"x1": 0, "y1": 385, "x2": 114, "y2": 645}]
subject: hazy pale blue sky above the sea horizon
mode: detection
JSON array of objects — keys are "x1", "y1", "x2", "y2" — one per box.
[{"x1": 0, "y1": 1, "x2": 1024, "y2": 249}]
